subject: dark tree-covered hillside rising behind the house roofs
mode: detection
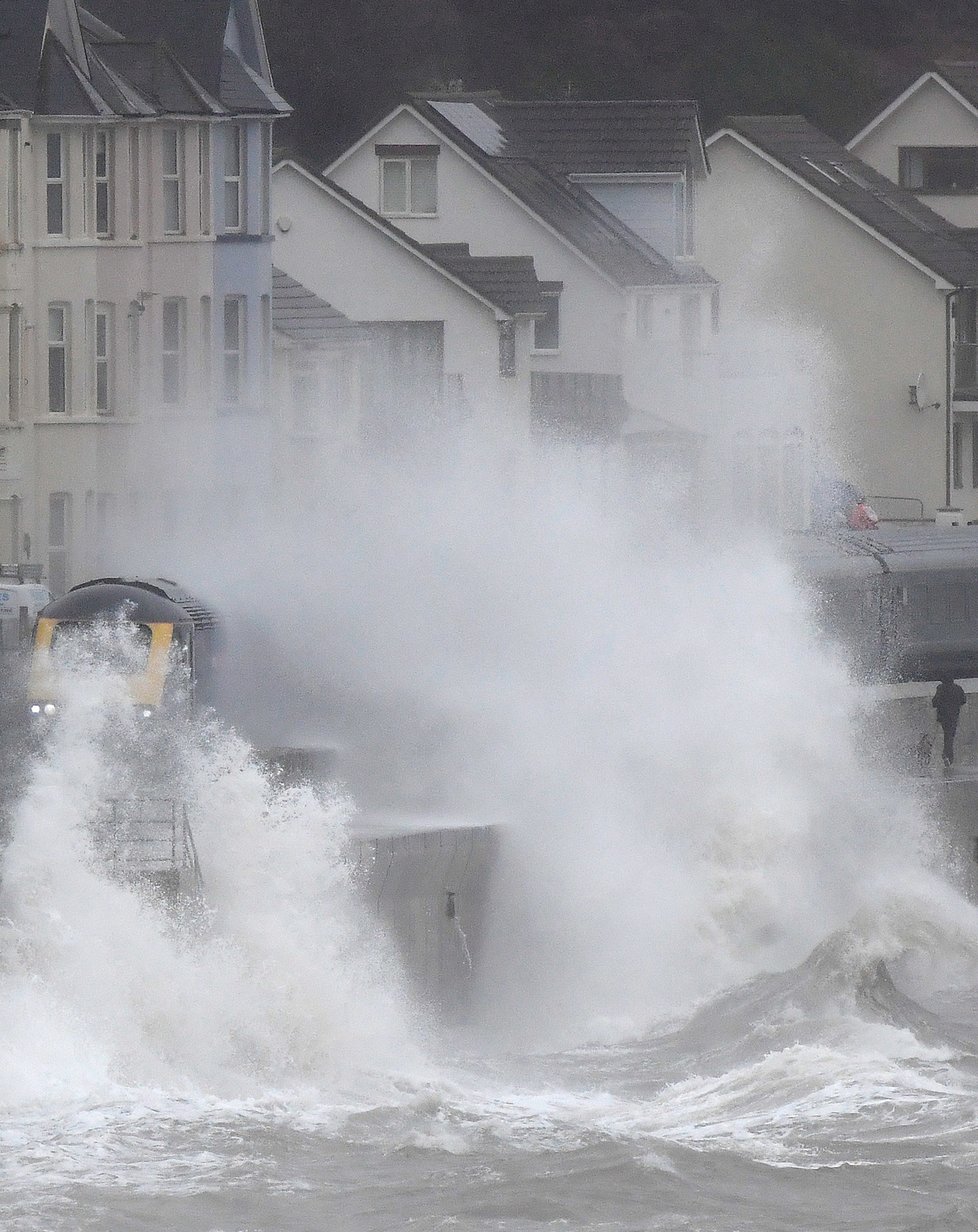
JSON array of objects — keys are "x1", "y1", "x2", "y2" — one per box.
[{"x1": 260, "y1": 0, "x2": 978, "y2": 160}]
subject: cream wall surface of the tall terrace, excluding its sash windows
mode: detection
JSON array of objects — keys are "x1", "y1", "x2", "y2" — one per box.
[{"x1": 0, "y1": 110, "x2": 278, "y2": 596}]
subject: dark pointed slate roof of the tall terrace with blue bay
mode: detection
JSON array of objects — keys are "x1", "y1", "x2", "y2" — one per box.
[{"x1": 0, "y1": 0, "x2": 289, "y2": 116}]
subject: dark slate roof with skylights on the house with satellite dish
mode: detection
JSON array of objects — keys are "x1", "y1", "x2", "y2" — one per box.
[{"x1": 721, "y1": 116, "x2": 978, "y2": 287}]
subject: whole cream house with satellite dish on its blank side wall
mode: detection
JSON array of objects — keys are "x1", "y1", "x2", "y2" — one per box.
[{"x1": 700, "y1": 116, "x2": 978, "y2": 517}]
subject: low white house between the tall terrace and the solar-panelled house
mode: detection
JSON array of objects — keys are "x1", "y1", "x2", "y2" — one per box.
[{"x1": 272, "y1": 159, "x2": 541, "y2": 458}]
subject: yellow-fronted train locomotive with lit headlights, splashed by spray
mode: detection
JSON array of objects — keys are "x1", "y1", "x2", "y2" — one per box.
[{"x1": 27, "y1": 577, "x2": 219, "y2": 719}]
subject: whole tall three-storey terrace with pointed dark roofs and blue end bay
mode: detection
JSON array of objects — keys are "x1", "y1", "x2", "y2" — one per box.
[{"x1": 0, "y1": 0, "x2": 288, "y2": 593}]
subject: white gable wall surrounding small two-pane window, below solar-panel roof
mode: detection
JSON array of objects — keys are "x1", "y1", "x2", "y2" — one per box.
[{"x1": 329, "y1": 111, "x2": 626, "y2": 372}]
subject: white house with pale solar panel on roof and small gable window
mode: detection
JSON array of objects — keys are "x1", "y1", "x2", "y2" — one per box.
[{"x1": 325, "y1": 94, "x2": 716, "y2": 450}]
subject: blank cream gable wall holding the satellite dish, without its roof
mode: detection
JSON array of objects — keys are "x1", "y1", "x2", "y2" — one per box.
[{"x1": 700, "y1": 137, "x2": 950, "y2": 516}]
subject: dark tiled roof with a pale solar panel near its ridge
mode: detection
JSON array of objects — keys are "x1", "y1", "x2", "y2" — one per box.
[{"x1": 414, "y1": 96, "x2": 713, "y2": 287}]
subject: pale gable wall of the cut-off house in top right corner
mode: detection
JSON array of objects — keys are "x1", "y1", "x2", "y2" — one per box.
[{"x1": 851, "y1": 81, "x2": 978, "y2": 227}]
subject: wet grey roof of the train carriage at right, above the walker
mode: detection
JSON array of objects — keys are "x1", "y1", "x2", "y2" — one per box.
[{"x1": 792, "y1": 524, "x2": 978, "y2": 577}]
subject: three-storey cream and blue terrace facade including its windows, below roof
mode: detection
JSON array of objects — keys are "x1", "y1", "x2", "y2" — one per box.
[{"x1": 0, "y1": 4, "x2": 285, "y2": 593}]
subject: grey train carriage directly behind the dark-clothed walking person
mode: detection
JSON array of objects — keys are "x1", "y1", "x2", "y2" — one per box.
[{"x1": 792, "y1": 524, "x2": 978, "y2": 683}]
